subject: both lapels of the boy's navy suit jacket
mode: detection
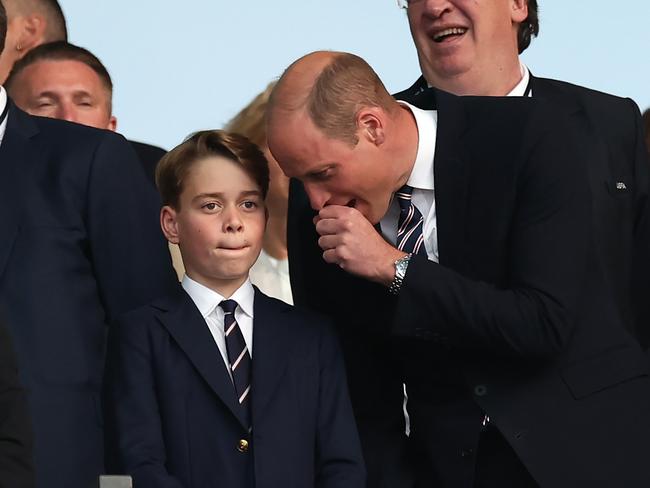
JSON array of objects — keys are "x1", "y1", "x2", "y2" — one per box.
[{"x1": 152, "y1": 284, "x2": 292, "y2": 427}]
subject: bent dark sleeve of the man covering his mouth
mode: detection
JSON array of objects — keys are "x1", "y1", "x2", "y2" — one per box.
[{"x1": 393, "y1": 114, "x2": 592, "y2": 357}]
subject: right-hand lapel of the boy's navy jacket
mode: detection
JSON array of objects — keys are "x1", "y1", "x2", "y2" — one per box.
[{"x1": 251, "y1": 288, "x2": 292, "y2": 428}]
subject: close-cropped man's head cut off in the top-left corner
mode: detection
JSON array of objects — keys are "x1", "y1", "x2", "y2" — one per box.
[{"x1": 0, "y1": 0, "x2": 68, "y2": 83}]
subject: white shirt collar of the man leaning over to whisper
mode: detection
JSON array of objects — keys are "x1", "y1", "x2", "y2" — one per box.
[{"x1": 398, "y1": 100, "x2": 438, "y2": 190}]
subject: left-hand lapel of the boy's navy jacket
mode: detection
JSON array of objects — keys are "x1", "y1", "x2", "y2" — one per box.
[{"x1": 156, "y1": 286, "x2": 248, "y2": 428}]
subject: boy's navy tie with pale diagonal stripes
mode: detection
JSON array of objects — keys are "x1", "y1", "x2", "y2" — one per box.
[{"x1": 219, "y1": 300, "x2": 252, "y2": 427}]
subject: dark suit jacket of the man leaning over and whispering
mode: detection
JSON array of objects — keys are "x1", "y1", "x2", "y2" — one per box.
[{"x1": 289, "y1": 90, "x2": 650, "y2": 487}]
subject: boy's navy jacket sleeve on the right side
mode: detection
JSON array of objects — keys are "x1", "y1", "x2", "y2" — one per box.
[{"x1": 316, "y1": 320, "x2": 366, "y2": 488}]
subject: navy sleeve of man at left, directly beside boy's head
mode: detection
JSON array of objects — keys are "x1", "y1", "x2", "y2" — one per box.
[{"x1": 85, "y1": 132, "x2": 177, "y2": 323}]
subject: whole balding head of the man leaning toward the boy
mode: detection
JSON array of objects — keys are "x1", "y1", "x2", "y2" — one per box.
[{"x1": 267, "y1": 52, "x2": 417, "y2": 223}]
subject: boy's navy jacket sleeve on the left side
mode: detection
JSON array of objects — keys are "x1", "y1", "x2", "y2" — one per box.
[{"x1": 103, "y1": 314, "x2": 183, "y2": 488}]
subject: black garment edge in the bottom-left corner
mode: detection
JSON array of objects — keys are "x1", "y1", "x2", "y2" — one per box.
[{"x1": 0, "y1": 321, "x2": 36, "y2": 488}]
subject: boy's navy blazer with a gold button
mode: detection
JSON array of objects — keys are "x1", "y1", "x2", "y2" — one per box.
[{"x1": 105, "y1": 287, "x2": 365, "y2": 488}]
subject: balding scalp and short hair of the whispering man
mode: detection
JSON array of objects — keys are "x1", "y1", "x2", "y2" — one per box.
[{"x1": 268, "y1": 51, "x2": 397, "y2": 145}]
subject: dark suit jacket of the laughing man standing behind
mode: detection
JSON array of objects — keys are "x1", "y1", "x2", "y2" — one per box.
[{"x1": 395, "y1": 76, "x2": 650, "y2": 348}]
